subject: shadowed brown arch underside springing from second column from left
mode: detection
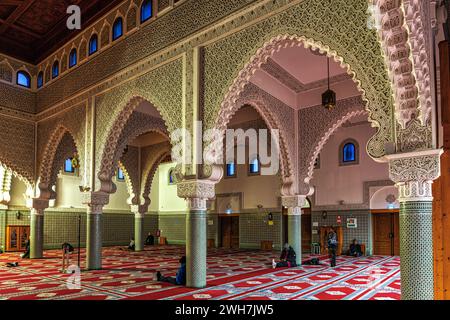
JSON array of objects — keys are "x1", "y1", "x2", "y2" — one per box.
[{"x1": 98, "y1": 102, "x2": 169, "y2": 193}]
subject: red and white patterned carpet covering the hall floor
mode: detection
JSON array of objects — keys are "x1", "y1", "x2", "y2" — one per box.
[{"x1": 0, "y1": 246, "x2": 400, "y2": 300}]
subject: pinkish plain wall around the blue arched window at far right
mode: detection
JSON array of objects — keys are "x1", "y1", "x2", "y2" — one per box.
[{"x1": 312, "y1": 123, "x2": 389, "y2": 205}]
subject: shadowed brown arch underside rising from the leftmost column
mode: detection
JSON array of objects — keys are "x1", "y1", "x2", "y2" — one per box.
[{"x1": 38, "y1": 124, "x2": 78, "y2": 199}]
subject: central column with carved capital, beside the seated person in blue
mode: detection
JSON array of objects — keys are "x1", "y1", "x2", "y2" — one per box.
[{"x1": 177, "y1": 180, "x2": 215, "y2": 288}]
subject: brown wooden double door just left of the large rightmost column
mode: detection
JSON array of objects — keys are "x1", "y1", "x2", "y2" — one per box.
[{"x1": 372, "y1": 211, "x2": 400, "y2": 256}]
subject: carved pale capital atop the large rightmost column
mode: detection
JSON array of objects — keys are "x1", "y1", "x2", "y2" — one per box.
[{"x1": 386, "y1": 149, "x2": 443, "y2": 202}]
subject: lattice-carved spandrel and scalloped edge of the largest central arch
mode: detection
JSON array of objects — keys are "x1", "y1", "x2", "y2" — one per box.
[{"x1": 204, "y1": 0, "x2": 394, "y2": 162}]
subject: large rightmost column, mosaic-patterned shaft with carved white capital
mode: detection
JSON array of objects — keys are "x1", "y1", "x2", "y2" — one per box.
[{"x1": 387, "y1": 150, "x2": 441, "y2": 300}]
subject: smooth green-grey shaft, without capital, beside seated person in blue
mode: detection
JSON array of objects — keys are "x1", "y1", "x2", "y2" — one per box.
[{"x1": 186, "y1": 209, "x2": 206, "y2": 288}]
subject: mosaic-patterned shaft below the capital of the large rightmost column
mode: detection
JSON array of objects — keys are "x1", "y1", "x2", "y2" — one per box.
[{"x1": 400, "y1": 201, "x2": 434, "y2": 300}]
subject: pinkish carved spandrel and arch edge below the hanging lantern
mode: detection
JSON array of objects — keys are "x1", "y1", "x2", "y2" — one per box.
[{"x1": 298, "y1": 97, "x2": 368, "y2": 196}]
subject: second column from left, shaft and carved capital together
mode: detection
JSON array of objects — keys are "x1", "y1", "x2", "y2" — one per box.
[{"x1": 83, "y1": 192, "x2": 109, "y2": 270}]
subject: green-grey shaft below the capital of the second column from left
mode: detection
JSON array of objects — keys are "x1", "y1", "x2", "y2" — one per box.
[{"x1": 86, "y1": 210, "x2": 102, "y2": 270}]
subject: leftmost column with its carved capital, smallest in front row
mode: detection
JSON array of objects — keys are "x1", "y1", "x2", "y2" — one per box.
[{"x1": 30, "y1": 199, "x2": 48, "y2": 259}]
